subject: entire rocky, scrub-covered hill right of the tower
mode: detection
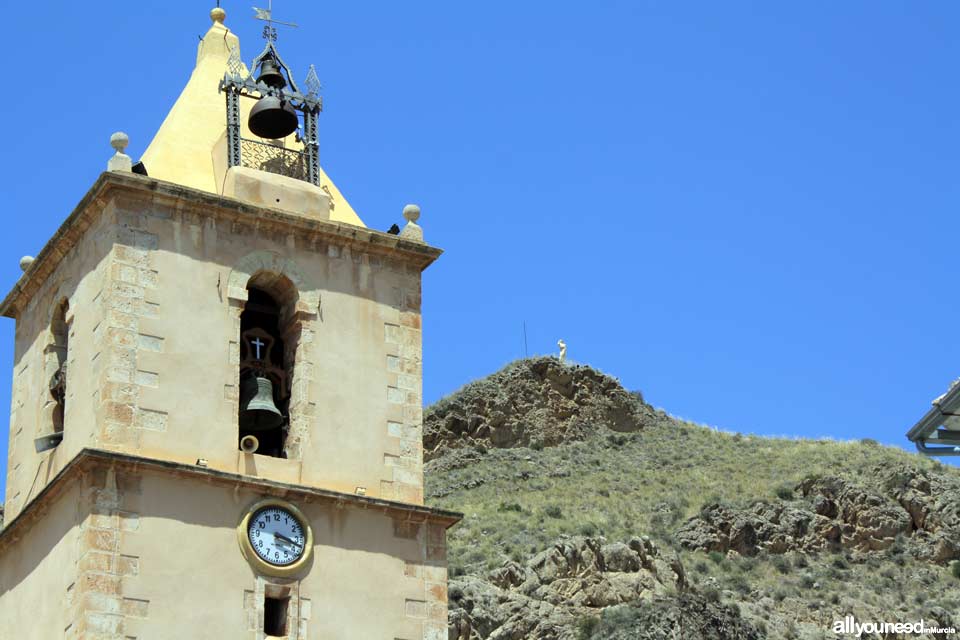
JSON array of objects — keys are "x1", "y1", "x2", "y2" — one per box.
[{"x1": 424, "y1": 358, "x2": 960, "y2": 640}]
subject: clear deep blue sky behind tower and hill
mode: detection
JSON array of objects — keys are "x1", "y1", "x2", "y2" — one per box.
[{"x1": 0, "y1": 0, "x2": 960, "y2": 490}]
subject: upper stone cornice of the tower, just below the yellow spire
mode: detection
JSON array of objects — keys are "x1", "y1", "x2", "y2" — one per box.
[{"x1": 0, "y1": 172, "x2": 443, "y2": 318}]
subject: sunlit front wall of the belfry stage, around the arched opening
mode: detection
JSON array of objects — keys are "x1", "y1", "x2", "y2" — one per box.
[{"x1": 97, "y1": 188, "x2": 423, "y2": 504}]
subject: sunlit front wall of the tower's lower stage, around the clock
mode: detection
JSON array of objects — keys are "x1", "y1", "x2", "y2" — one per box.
[{"x1": 67, "y1": 470, "x2": 447, "y2": 640}]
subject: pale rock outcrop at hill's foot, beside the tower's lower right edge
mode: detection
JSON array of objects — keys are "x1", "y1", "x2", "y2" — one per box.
[{"x1": 450, "y1": 537, "x2": 756, "y2": 640}]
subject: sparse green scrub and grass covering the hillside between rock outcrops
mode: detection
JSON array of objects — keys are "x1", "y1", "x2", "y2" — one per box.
[{"x1": 426, "y1": 358, "x2": 960, "y2": 640}]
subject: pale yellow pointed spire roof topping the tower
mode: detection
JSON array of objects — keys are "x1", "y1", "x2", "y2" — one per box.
[{"x1": 143, "y1": 7, "x2": 365, "y2": 227}]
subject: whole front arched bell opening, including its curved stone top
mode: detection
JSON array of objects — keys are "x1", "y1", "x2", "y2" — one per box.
[{"x1": 237, "y1": 273, "x2": 297, "y2": 458}]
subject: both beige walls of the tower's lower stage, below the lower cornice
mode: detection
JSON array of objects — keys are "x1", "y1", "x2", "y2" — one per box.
[{"x1": 0, "y1": 462, "x2": 447, "y2": 640}]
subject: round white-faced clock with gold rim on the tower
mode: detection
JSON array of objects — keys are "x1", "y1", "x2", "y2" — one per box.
[{"x1": 237, "y1": 499, "x2": 313, "y2": 576}]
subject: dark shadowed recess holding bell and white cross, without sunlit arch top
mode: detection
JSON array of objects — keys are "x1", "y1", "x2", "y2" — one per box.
[{"x1": 237, "y1": 287, "x2": 293, "y2": 458}]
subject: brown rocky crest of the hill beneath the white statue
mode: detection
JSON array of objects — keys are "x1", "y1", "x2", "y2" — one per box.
[{"x1": 423, "y1": 357, "x2": 662, "y2": 460}]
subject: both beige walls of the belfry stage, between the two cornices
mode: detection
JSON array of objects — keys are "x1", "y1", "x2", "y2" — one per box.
[{"x1": 6, "y1": 182, "x2": 434, "y2": 510}]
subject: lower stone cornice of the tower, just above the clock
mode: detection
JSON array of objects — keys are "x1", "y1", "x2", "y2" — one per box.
[{"x1": 0, "y1": 449, "x2": 463, "y2": 553}]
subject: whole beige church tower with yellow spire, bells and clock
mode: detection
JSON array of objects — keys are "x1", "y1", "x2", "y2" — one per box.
[{"x1": 0, "y1": 8, "x2": 460, "y2": 640}]
